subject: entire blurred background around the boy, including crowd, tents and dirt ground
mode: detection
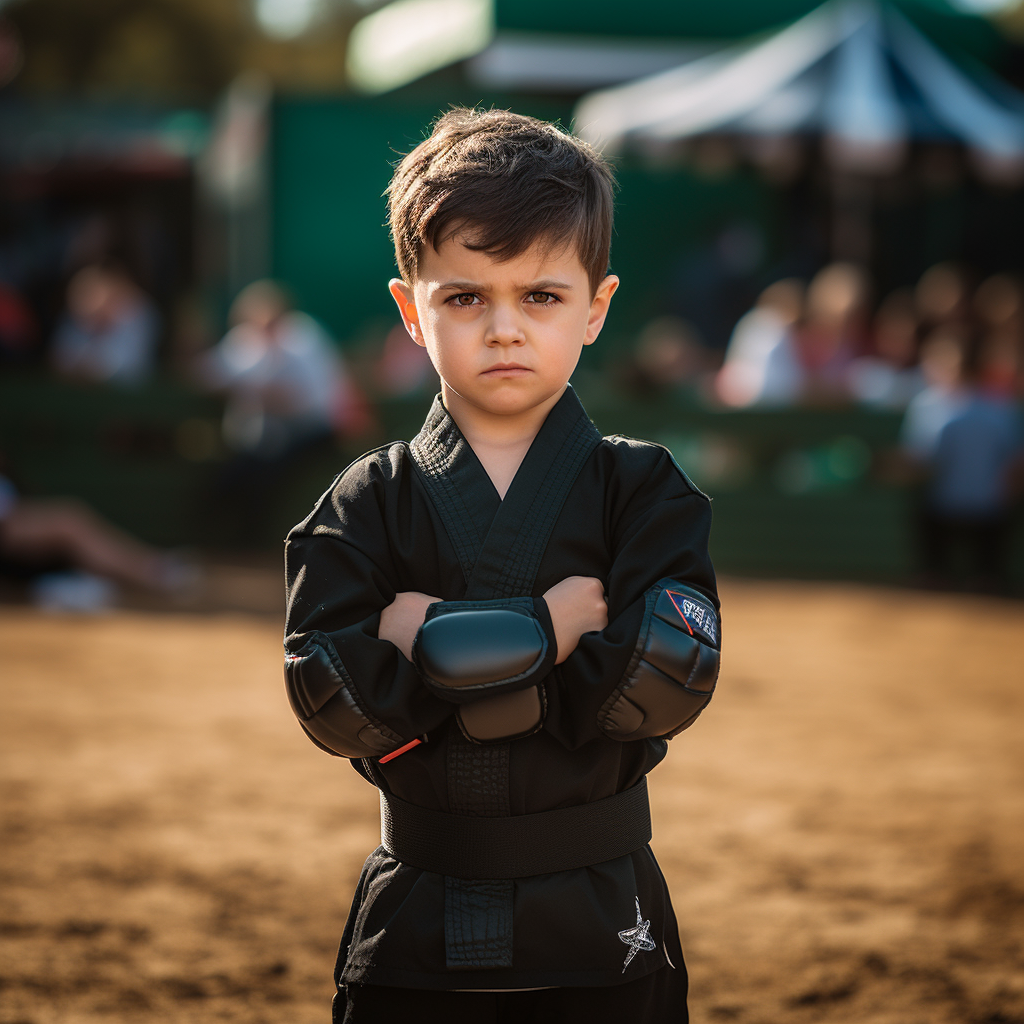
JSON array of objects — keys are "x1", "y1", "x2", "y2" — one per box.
[{"x1": 0, "y1": 0, "x2": 1024, "y2": 1024}]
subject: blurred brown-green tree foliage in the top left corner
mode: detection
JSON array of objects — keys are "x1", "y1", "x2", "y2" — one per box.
[{"x1": 4, "y1": 0, "x2": 354, "y2": 102}]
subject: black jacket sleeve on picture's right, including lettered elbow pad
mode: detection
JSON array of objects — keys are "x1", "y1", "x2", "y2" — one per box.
[{"x1": 544, "y1": 445, "x2": 721, "y2": 749}]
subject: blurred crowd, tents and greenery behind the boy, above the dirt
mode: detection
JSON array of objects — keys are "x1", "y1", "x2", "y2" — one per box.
[{"x1": 0, "y1": 0, "x2": 1024, "y2": 600}]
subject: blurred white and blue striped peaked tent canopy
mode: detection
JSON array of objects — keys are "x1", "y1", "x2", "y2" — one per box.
[{"x1": 575, "y1": 0, "x2": 1024, "y2": 177}]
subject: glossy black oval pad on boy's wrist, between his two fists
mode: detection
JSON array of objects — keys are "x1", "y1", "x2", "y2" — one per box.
[{"x1": 413, "y1": 597, "x2": 556, "y2": 703}]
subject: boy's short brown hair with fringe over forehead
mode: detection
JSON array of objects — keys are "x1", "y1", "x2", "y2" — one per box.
[{"x1": 387, "y1": 108, "x2": 614, "y2": 293}]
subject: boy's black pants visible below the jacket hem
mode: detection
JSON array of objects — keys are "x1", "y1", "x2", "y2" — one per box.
[{"x1": 334, "y1": 963, "x2": 689, "y2": 1024}]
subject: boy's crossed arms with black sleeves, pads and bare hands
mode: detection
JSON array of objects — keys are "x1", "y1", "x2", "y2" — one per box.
[{"x1": 286, "y1": 448, "x2": 720, "y2": 758}]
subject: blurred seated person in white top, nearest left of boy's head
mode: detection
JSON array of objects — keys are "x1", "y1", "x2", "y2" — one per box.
[{"x1": 199, "y1": 281, "x2": 352, "y2": 461}]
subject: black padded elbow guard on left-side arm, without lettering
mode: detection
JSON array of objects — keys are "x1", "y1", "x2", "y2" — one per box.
[{"x1": 285, "y1": 633, "x2": 404, "y2": 758}]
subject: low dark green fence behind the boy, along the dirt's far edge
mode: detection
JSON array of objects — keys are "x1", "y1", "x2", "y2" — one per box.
[{"x1": 0, "y1": 375, "x2": 1024, "y2": 584}]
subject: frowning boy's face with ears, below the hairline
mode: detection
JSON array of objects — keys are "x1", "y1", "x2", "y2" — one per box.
[{"x1": 391, "y1": 233, "x2": 618, "y2": 426}]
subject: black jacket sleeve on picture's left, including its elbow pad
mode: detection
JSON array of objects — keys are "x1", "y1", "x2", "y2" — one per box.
[{"x1": 285, "y1": 460, "x2": 454, "y2": 758}]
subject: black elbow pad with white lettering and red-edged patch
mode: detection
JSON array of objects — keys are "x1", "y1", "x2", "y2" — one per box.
[{"x1": 598, "y1": 580, "x2": 721, "y2": 740}]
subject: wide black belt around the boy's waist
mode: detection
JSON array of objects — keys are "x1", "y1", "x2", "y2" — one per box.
[{"x1": 381, "y1": 778, "x2": 650, "y2": 879}]
